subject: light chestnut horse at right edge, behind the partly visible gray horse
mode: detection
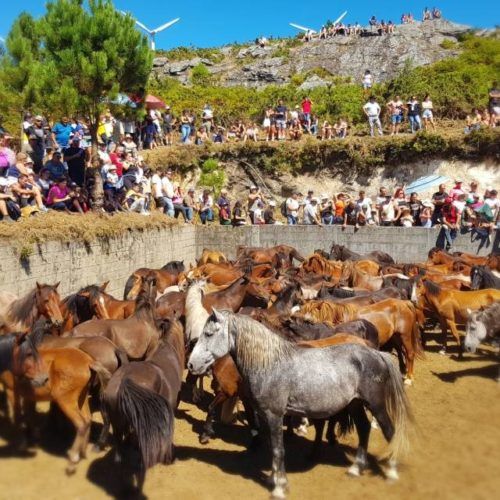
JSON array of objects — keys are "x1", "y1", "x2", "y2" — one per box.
[{"x1": 412, "y1": 279, "x2": 500, "y2": 356}]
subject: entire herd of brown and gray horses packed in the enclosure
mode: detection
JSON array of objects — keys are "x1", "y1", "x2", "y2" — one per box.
[{"x1": 0, "y1": 244, "x2": 500, "y2": 498}]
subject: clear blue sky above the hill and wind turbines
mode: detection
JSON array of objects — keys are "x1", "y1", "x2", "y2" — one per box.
[{"x1": 0, "y1": 0, "x2": 500, "y2": 49}]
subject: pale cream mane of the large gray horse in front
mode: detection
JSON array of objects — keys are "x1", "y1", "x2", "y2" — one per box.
[{"x1": 228, "y1": 311, "x2": 296, "y2": 373}]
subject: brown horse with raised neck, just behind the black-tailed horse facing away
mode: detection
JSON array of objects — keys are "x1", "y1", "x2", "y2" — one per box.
[{"x1": 66, "y1": 273, "x2": 161, "y2": 360}]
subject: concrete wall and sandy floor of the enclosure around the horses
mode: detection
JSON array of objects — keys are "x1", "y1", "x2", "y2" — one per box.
[{"x1": 0, "y1": 226, "x2": 500, "y2": 500}]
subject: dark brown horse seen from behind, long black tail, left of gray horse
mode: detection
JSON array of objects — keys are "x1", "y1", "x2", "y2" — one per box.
[{"x1": 103, "y1": 320, "x2": 185, "y2": 492}]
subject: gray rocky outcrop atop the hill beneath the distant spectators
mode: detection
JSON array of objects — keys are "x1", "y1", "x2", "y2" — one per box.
[{"x1": 153, "y1": 19, "x2": 470, "y2": 89}]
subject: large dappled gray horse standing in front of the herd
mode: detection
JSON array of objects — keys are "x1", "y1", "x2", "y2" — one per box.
[{"x1": 188, "y1": 309, "x2": 412, "y2": 498}]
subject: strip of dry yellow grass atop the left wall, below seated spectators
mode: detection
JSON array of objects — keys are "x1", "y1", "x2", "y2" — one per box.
[{"x1": 0, "y1": 212, "x2": 180, "y2": 258}]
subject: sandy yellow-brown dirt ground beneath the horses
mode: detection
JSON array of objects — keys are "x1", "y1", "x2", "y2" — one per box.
[{"x1": 0, "y1": 334, "x2": 500, "y2": 500}]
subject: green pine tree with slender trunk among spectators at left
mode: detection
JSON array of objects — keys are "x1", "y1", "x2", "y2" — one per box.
[{"x1": 2, "y1": 0, "x2": 152, "y2": 208}]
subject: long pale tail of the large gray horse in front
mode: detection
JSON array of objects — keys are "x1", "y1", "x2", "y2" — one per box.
[{"x1": 379, "y1": 352, "x2": 414, "y2": 458}]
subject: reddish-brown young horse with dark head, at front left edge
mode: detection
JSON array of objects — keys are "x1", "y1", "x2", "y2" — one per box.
[{"x1": 0, "y1": 328, "x2": 111, "y2": 475}]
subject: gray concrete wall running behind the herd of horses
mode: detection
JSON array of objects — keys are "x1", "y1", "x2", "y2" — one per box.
[{"x1": 0, "y1": 225, "x2": 499, "y2": 297}]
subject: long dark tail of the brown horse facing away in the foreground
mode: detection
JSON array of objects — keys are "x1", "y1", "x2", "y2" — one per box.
[{"x1": 117, "y1": 379, "x2": 174, "y2": 470}]
